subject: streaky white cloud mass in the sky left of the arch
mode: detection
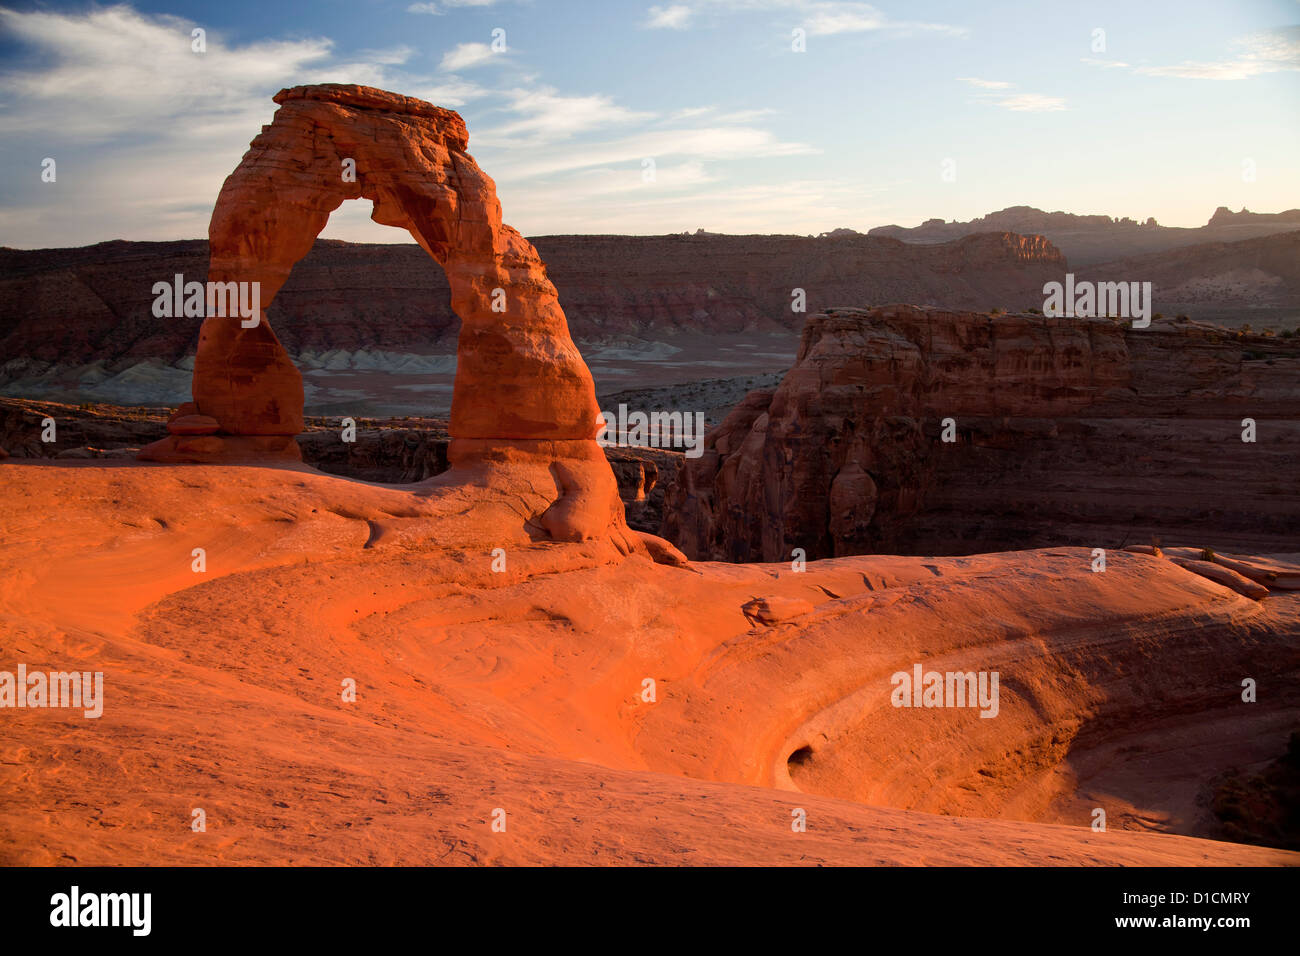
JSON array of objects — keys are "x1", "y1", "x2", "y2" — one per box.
[{"x1": 0, "y1": 5, "x2": 452, "y2": 246}]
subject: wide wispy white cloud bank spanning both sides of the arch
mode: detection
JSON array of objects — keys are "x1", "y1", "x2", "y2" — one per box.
[{"x1": 0, "y1": 4, "x2": 832, "y2": 247}]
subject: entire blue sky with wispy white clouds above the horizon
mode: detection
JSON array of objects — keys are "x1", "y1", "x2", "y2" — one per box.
[{"x1": 0, "y1": 0, "x2": 1300, "y2": 248}]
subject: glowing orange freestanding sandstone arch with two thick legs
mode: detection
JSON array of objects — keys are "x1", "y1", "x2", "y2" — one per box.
[{"x1": 140, "y1": 83, "x2": 632, "y2": 554}]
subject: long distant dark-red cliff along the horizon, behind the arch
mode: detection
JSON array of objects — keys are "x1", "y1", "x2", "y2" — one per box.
[{"x1": 0, "y1": 233, "x2": 1066, "y2": 407}]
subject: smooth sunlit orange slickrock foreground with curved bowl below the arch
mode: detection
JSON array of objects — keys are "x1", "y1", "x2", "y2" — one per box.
[{"x1": 0, "y1": 459, "x2": 1300, "y2": 865}]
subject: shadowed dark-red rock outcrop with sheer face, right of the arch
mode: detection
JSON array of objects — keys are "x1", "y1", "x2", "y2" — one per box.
[{"x1": 663, "y1": 306, "x2": 1300, "y2": 561}]
